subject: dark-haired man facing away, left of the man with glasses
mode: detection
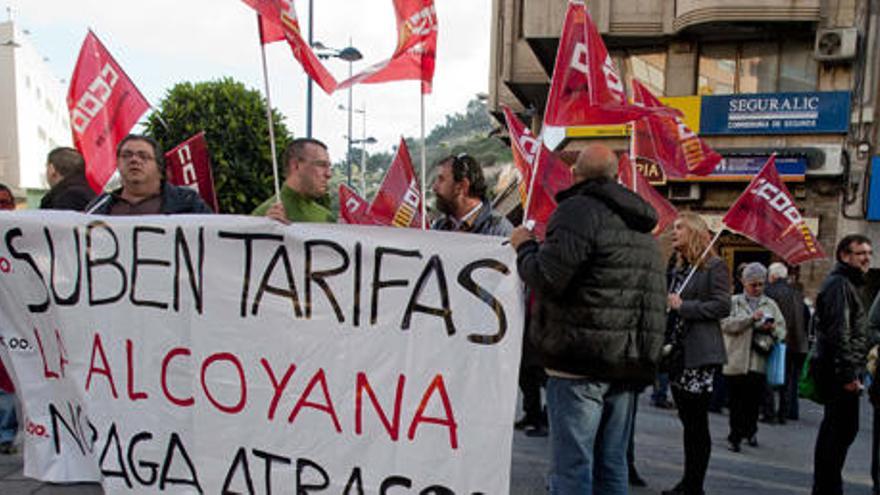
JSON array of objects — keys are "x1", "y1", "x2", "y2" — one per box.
[{"x1": 40, "y1": 147, "x2": 95, "y2": 211}]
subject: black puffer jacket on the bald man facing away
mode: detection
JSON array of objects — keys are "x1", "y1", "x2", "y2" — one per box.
[{"x1": 517, "y1": 180, "x2": 666, "y2": 384}]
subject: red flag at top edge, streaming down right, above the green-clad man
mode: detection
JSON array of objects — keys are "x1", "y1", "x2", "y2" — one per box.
[{"x1": 242, "y1": 0, "x2": 336, "y2": 94}]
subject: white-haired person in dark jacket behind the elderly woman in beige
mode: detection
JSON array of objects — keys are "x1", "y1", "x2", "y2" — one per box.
[{"x1": 764, "y1": 262, "x2": 809, "y2": 424}]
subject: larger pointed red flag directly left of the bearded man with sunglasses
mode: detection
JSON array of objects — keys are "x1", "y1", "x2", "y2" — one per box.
[{"x1": 370, "y1": 138, "x2": 422, "y2": 228}]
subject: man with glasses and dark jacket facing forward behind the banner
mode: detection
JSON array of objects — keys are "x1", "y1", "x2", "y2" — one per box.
[{"x1": 86, "y1": 134, "x2": 213, "y2": 215}]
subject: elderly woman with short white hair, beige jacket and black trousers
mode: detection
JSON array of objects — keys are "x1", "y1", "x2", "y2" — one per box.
[{"x1": 721, "y1": 263, "x2": 785, "y2": 452}]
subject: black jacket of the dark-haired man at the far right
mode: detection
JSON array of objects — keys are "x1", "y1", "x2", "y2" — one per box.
[{"x1": 814, "y1": 262, "x2": 868, "y2": 390}]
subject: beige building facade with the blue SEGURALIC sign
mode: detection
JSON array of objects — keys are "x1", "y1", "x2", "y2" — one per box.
[{"x1": 489, "y1": 0, "x2": 880, "y2": 294}]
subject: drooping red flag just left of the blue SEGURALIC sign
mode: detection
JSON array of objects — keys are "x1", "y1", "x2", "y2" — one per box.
[{"x1": 632, "y1": 79, "x2": 721, "y2": 178}]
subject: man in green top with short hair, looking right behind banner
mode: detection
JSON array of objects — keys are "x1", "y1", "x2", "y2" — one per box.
[{"x1": 251, "y1": 138, "x2": 336, "y2": 224}]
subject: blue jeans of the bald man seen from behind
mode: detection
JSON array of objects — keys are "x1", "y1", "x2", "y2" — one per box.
[{"x1": 547, "y1": 376, "x2": 635, "y2": 495}]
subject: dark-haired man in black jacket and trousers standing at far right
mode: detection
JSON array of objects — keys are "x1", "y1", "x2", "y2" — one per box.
[{"x1": 812, "y1": 234, "x2": 873, "y2": 495}]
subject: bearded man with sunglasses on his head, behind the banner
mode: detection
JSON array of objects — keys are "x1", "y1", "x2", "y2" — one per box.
[{"x1": 431, "y1": 153, "x2": 513, "y2": 237}]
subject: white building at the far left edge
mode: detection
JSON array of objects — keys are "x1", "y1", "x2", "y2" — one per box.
[{"x1": 0, "y1": 21, "x2": 72, "y2": 206}]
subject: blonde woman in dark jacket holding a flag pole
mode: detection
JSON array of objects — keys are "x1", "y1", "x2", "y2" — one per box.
[{"x1": 663, "y1": 212, "x2": 730, "y2": 495}]
